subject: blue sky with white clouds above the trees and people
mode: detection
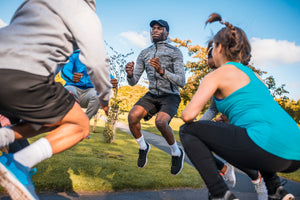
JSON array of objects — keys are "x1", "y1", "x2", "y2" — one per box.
[{"x1": 0, "y1": 0, "x2": 300, "y2": 100}]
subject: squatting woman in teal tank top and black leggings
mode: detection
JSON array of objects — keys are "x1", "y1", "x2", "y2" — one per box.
[{"x1": 180, "y1": 13, "x2": 300, "y2": 200}]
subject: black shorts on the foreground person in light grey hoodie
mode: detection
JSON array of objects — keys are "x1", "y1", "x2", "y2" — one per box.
[{"x1": 0, "y1": 69, "x2": 75, "y2": 129}]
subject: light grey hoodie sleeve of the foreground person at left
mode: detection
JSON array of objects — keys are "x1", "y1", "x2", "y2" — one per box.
[{"x1": 65, "y1": 1, "x2": 113, "y2": 105}]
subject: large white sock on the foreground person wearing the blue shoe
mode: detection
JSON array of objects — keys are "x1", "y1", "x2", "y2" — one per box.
[{"x1": 14, "y1": 138, "x2": 52, "y2": 168}]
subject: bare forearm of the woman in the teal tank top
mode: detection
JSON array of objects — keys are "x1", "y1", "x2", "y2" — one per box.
[{"x1": 181, "y1": 71, "x2": 219, "y2": 123}]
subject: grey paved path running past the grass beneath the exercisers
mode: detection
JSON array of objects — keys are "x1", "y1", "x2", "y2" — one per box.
[{"x1": 0, "y1": 120, "x2": 300, "y2": 200}]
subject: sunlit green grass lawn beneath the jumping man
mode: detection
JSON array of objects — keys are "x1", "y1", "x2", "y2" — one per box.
[{"x1": 0, "y1": 120, "x2": 204, "y2": 192}]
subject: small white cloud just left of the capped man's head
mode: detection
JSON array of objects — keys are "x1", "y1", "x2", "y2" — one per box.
[{"x1": 120, "y1": 31, "x2": 150, "y2": 48}]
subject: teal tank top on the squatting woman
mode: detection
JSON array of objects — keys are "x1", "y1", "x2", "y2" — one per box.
[{"x1": 214, "y1": 62, "x2": 300, "y2": 160}]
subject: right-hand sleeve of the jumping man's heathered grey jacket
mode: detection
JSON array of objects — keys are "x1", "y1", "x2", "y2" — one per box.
[{"x1": 163, "y1": 48, "x2": 185, "y2": 87}]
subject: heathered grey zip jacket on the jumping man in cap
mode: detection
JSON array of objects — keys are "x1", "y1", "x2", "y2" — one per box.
[{"x1": 127, "y1": 39, "x2": 185, "y2": 95}]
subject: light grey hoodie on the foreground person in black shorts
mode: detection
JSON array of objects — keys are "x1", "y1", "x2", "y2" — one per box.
[{"x1": 0, "y1": 0, "x2": 112, "y2": 105}]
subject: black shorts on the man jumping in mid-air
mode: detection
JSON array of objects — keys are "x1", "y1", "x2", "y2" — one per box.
[{"x1": 135, "y1": 92, "x2": 181, "y2": 121}]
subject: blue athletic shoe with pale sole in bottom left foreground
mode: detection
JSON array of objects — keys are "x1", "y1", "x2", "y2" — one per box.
[{"x1": 0, "y1": 154, "x2": 39, "y2": 200}]
